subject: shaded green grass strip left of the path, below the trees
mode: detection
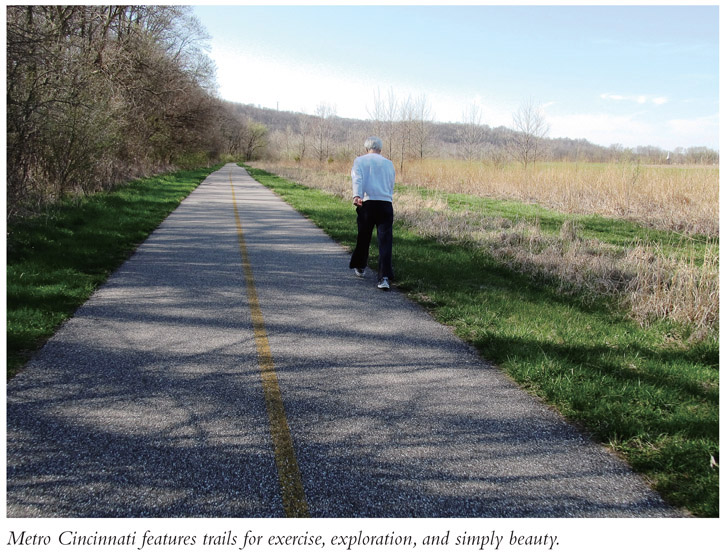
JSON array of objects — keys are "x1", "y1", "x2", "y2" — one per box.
[{"x1": 6, "y1": 164, "x2": 221, "y2": 378}]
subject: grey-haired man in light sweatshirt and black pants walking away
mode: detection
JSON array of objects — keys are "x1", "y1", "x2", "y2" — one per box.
[{"x1": 349, "y1": 136, "x2": 395, "y2": 290}]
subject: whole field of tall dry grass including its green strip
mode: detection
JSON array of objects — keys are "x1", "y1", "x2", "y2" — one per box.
[{"x1": 255, "y1": 159, "x2": 719, "y2": 339}]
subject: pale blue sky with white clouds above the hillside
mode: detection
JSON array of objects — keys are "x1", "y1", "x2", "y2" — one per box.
[{"x1": 194, "y1": 4, "x2": 719, "y2": 149}]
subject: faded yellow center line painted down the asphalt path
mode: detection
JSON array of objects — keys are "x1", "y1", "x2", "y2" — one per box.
[{"x1": 229, "y1": 167, "x2": 309, "y2": 517}]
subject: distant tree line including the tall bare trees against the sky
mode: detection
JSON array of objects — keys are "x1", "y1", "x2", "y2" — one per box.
[{"x1": 235, "y1": 98, "x2": 719, "y2": 171}]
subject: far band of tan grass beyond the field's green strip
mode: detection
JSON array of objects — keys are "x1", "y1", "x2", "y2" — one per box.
[{"x1": 401, "y1": 159, "x2": 719, "y2": 236}]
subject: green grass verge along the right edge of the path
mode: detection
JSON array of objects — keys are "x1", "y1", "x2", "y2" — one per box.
[{"x1": 247, "y1": 167, "x2": 719, "y2": 517}]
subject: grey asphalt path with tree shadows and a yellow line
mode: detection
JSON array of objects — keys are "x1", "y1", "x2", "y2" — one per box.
[{"x1": 7, "y1": 165, "x2": 680, "y2": 517}]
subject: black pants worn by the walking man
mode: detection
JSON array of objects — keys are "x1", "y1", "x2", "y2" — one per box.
[{"x1": 349, "y1": 200, "x2": 394, "y2": 280}]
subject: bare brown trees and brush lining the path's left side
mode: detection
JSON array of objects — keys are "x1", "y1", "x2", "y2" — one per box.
[{"x1": 7, "y1": 5, "x2": 258, "y2": 217}]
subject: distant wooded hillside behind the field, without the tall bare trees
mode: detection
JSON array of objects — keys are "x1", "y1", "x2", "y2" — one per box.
[{"x1": 226, "y1": 104, "x2": 719, "y2": 165}]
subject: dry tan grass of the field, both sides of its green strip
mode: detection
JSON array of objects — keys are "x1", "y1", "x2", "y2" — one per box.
[{"x1": 252, "y1": 161, "x2": 719, "y2": 337}]
